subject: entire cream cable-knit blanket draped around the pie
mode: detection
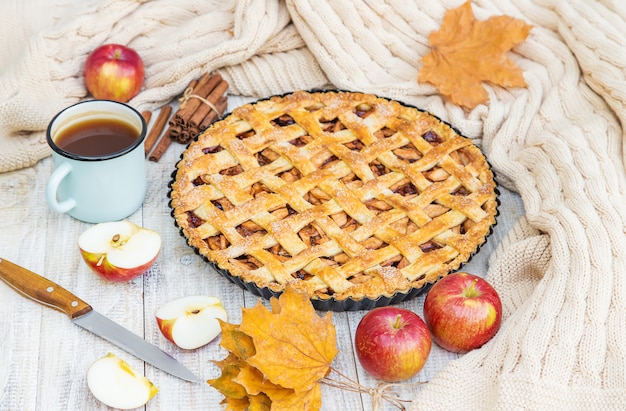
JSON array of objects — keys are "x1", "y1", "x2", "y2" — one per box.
[{"x1": 0, "y1": 0, "x2": 626, "y2": 410}]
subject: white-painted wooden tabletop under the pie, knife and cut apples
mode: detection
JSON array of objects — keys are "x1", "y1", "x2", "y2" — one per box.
[{"x1": 0, "y1": 96, "x2": 523, "y2": 411}]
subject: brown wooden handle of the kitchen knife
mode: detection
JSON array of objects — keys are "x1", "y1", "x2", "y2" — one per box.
[{"x1": 0, "y1": 258, "x2": 92, "y2": 319}]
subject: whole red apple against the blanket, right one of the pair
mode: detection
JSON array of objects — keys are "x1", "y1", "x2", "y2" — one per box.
[{"x1": 424, "y1": 272, "x2": 502, "y2": 353}]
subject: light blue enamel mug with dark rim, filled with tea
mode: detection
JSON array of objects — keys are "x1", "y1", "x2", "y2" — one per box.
[{"x1": 46, "y1": 100, "x2": 147, "y2": 223}]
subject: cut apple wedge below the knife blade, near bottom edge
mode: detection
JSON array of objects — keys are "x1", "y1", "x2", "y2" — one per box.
[{"x1": 87, "y1": 353, "x2": 159, "y2": 410}]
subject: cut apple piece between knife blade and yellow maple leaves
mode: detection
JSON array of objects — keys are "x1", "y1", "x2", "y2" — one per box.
[{"x1": 155, "y1": 295, "x2": 228, "y2": 350}]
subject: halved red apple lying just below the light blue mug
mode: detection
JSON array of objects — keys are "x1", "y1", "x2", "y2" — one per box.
[{"x1": 78, "y1": 220, "x2": 161, "y2": 282}]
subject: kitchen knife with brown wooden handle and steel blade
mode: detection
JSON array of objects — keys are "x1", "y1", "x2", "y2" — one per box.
[{"x1": 0, "y1": 258, "x2": 201, "y2": 382}]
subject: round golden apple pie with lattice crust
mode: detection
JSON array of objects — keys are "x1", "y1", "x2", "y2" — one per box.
[{"x1": 169, "y1": 91, "x2": 497, "y2": 310}]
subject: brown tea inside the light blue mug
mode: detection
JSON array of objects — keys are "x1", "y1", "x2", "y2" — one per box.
[{"x1": 54, "y1": 118, "x2": 140, "y2": 157}]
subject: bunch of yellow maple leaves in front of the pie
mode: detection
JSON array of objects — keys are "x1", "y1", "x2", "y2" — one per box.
[{"x1": 208, "y1": 287, "x2": 338, "y2": 411}]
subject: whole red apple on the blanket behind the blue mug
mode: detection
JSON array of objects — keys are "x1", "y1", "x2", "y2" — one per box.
[{"x1": 84, "y1": 44, "x2": 144, "y2": 103}]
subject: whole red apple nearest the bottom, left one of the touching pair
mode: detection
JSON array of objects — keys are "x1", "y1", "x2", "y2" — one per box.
[{"x1": 354, "y1": 307, "x2": 432, "y2": 382}]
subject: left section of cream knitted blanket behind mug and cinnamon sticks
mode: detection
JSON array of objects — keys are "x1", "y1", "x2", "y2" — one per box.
[{"x1": 0, "y1": 0, "x2": 327, "y2": 172}]
